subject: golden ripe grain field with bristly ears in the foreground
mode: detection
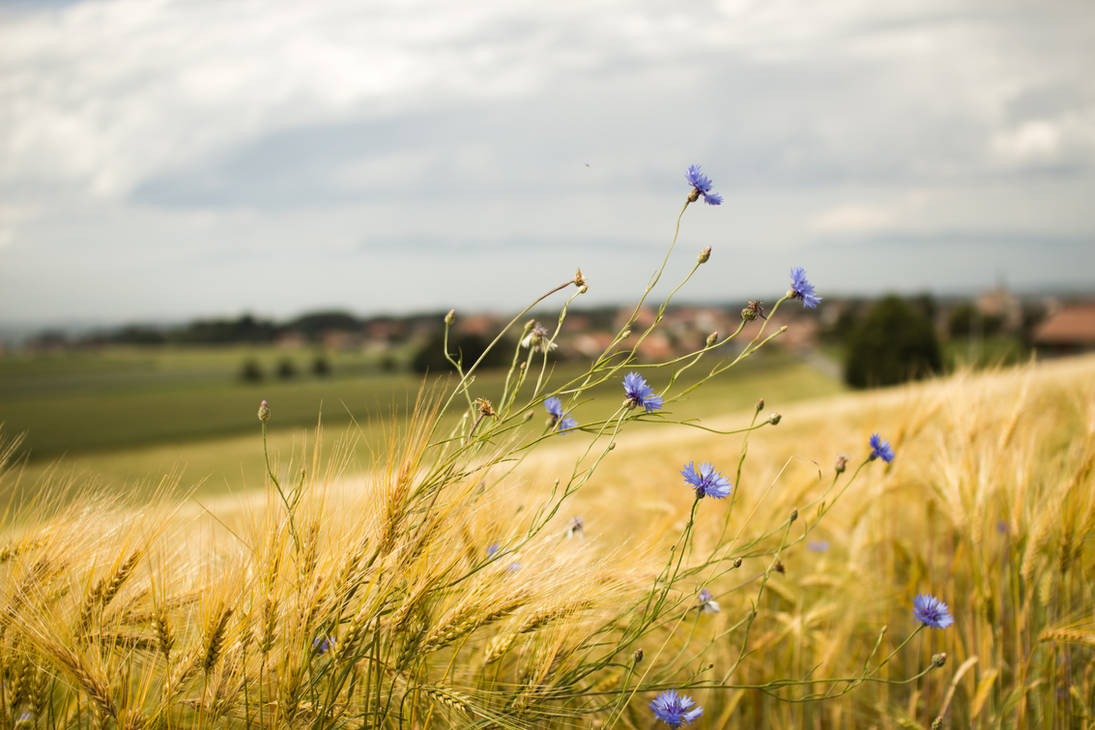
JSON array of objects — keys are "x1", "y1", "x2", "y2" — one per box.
[{"x1": 0, "y1": 357, "x2": 1095, "y2": 728}]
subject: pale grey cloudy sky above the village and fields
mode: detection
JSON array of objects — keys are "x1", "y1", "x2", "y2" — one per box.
[{"x1": 0, "y1": 0, "x2": 1095, "y2": 322}]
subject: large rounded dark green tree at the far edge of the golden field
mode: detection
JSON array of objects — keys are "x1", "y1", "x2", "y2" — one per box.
[{"x1": 844, "y1": 296, "x2": 943, "y2": 387}]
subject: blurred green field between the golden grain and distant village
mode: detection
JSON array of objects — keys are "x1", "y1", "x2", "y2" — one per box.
[{"x1": 0, "y1": 348, "x2": 843, "y2": 497}]
